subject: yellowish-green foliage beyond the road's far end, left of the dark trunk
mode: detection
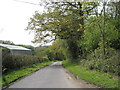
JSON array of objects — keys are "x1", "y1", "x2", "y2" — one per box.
[{"x1": 35, "y1": 39, "x2": 72, "y2": 60}]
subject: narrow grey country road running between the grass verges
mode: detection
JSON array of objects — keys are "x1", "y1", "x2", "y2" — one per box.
[{"x1": 9, "y1": 62, "x2": 97, "y2": 88}]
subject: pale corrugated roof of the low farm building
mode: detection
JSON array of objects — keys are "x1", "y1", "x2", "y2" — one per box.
[{"x1": 0, "y1": 44, "x2": 30, "y2": 50}]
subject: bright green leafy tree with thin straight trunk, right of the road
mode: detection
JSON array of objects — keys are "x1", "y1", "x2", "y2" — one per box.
[{"x1": 82, "y1": 0, "x2": 120, "y2": 59}]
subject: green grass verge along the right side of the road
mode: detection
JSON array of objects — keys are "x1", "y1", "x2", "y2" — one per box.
[{"x1": 63, "y1": 61, "x2": 120, "y2": 89}]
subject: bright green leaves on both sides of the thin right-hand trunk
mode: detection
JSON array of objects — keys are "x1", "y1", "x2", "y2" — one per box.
[{"x1": 81, "y1": 16, "x2": 120, "y2": 51}]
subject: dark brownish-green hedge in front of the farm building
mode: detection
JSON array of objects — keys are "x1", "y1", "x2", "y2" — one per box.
[{"x1": 2, "y1": 54, "x2": 48, "y2": 73}]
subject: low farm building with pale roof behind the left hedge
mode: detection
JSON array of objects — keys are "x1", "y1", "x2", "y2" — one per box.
[{"x1": 0, "y1": 44, "x2": 32, "y2": 55}]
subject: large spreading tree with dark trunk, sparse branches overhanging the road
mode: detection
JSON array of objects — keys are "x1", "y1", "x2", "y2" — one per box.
[{"x1": 27, "y1": 2, "x2": 96, "y2": 62}]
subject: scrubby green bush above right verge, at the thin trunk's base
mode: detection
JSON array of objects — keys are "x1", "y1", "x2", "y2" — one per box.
[{"x1": 80, "y1": 48, "x2": 120, "y2": 76}]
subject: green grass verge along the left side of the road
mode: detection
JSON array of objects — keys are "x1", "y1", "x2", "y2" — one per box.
[{"x1": 2, "y1": 61, "x2": 52, "y2": 86}]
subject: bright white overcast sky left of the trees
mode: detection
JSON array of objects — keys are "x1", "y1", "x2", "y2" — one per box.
[{"x1": 0, "y1": 0, "x2": 44, "y2": 46}]
